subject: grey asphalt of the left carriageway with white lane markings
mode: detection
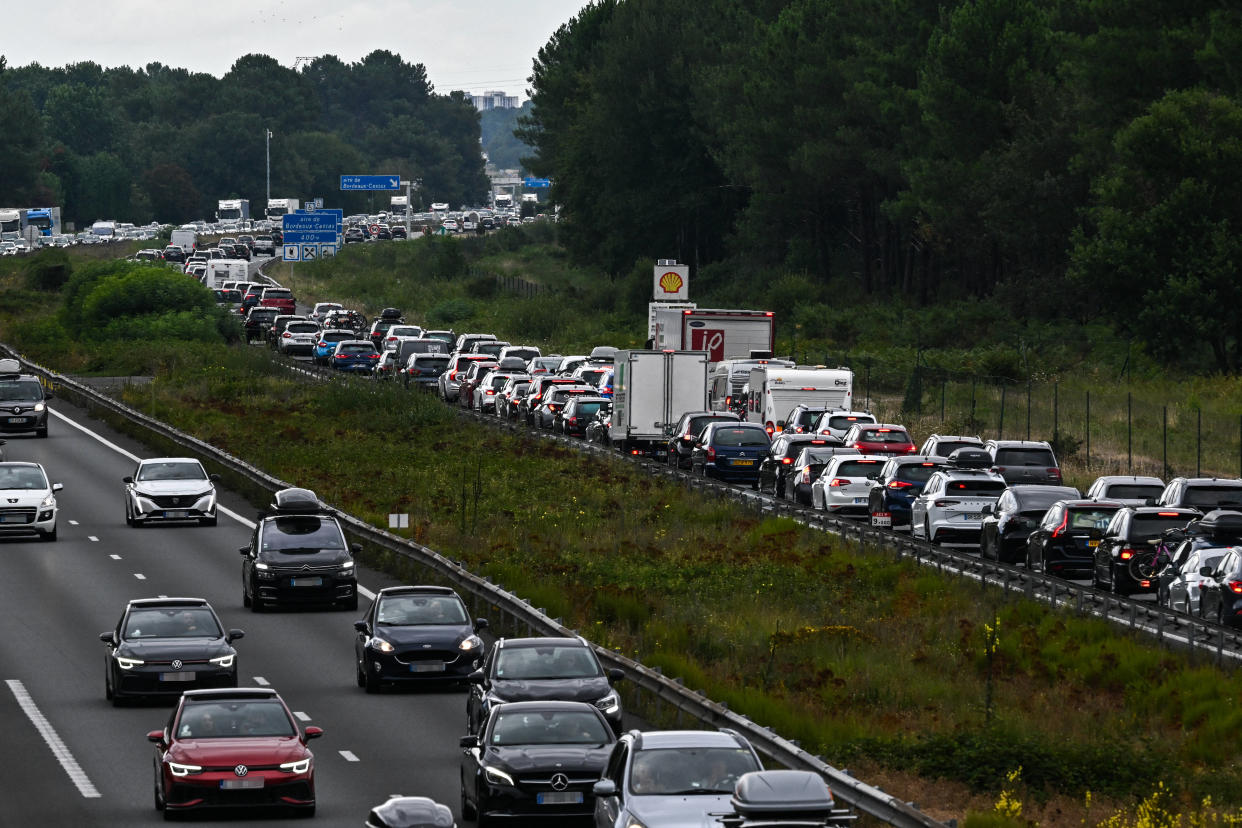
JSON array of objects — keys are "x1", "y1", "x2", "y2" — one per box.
[{"x1": 0, "y1": 400, "x2": 466, "y2": 827}]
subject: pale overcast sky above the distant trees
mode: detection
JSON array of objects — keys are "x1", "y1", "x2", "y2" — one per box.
[{"x1": 0, "y1": 0, "x2": 586, "y2": 98}]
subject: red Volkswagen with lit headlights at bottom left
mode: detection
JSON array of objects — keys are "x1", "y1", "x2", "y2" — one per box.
[{"x1": 147, "y1": 688, "x2": 323, "y2": 817}]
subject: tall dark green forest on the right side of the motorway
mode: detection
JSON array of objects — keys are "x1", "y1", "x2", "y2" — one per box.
[{"x1": 519, "y1": 0, "x2": 1242, "y2": 371}]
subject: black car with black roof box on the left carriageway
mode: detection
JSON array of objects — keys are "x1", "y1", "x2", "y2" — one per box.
[{"x1": 238, "y1": 489, "x2": 361, "y2": 612}]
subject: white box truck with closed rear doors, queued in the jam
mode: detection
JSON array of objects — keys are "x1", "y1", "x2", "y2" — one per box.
[{"x1": 609, "y1": 350, "x2": 708, "y2": 454}]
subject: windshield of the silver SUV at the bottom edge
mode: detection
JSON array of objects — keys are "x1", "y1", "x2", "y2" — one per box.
[{"x1": 630, "y1": 747, "x2": 760, "y2": 796}]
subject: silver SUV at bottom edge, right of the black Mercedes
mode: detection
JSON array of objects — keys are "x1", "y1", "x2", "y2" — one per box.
[{"x1": 592, "y1": 730, "x2": 763, "y2": 828}]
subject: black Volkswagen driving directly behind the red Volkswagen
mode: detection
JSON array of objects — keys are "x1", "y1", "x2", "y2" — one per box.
[{"x1": 99, "y1": 598, "x2": 246, "y2": 706}]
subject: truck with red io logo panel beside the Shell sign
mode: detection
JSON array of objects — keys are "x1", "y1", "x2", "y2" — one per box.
[{"x1": 650, "y1": 303, "x2": 776, "y2": 362}]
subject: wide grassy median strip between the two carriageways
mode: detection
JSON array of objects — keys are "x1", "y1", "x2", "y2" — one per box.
[{"x1": 0, "y1": 243, "x2": 1242, "y2": 826}]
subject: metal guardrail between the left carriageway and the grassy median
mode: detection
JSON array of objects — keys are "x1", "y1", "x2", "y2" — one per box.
[{"x1": 0, "y1": 344, "x2": 945, "y2": 828}]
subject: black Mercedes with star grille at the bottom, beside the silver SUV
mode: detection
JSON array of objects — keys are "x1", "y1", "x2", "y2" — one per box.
[{"x1": 461, "y1": 701, "x2": 616, "y2": 828}]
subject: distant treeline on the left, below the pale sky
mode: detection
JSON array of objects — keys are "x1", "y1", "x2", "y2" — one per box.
[{"x1": 0, "y1": 51, "x2": 488, "y2": 227}]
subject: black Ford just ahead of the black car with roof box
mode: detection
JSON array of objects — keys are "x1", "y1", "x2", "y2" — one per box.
[{"x1": 354, "y1": 586, "x2": 487, "y2": 693}]
